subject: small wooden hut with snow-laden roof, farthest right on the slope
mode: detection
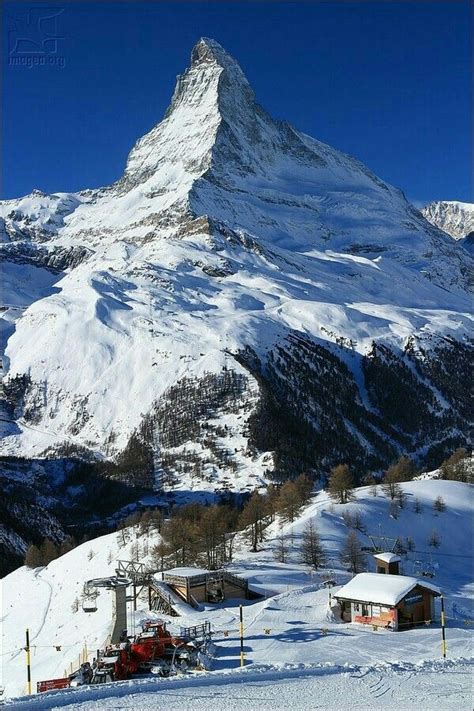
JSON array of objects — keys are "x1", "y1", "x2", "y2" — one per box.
[{"x1": 334, "y1": 573, "x2": 441, "y2": 630}]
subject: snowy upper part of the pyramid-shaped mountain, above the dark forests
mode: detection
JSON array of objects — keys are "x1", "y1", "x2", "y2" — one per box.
[{"x1": 1, "y1": 39, "x2": 471, "y2": 466}]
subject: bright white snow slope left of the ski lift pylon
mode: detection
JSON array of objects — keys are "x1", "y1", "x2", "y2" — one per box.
[{"x1": 0, "y1": 528, "x2": 165, "y2": 695}]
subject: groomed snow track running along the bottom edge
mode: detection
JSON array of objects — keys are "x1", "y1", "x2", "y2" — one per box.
[{"x1": 7, "y1": 660, "x2": 473, "y2": 711}]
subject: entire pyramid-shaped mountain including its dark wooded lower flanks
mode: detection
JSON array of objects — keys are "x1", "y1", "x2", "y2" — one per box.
[{"x1": 0, "y1": 39, "x2": 472, "y2": 544}]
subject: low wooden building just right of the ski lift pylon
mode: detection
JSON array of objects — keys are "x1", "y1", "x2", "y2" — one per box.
[{"x1": 163, "y1": 568, "x2": 254, "y2": 605}]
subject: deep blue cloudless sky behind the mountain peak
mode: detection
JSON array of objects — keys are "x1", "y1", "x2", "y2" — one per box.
[{"x1": 2, "y1": 0, "x2": 473, "y2": 202}]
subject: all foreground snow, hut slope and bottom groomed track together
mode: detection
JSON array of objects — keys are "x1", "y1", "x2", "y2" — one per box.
[{"x1": 1, "y1": 478, "x2": 474, "y2": 711}]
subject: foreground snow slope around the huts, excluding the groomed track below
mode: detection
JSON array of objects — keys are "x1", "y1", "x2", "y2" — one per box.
[{"x1": 1, "y1": 480, "x2": 474, "y2": 708}]
